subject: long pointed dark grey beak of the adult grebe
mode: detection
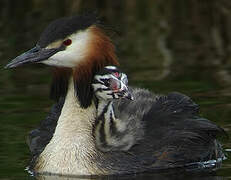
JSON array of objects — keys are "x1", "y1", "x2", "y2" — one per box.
[{"x1": 5, "y1": 45, "x2": 63, "y2": 69}]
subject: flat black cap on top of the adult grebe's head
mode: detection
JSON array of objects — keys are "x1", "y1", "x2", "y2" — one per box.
[{"x1": 37, "y1": 14, "x2": 99, "y2": 47}]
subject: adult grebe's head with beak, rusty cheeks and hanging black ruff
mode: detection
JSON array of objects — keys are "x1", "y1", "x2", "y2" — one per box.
[{"x1": 5, "y1": 14, "x2": 119, "y2": 108}]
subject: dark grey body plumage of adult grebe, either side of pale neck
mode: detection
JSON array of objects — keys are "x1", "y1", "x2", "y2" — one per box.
[{"x1": 29, "y1": 88, "x2": 224, "y2": 174}]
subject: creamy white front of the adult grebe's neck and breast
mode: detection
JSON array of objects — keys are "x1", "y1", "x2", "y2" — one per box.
[{"x1": 35, "y1": 78, "x2": 103, "y2": 175}]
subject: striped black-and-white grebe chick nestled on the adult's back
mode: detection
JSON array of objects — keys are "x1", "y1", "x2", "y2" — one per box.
[{"x1": 92, "y1": 66, "x2": 133, "y2": 152}]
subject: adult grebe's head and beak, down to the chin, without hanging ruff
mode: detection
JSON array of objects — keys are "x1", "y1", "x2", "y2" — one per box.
[{"x1": 6, "y1": 15, "x2": 118, "y2": 68}]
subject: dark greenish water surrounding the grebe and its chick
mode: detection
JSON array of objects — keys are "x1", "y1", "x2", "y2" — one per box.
[{"x1": 0, "y1": 0, "x2": 231, "y2": 179}]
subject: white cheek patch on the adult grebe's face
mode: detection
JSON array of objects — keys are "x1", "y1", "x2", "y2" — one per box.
[{"x1": 42, "y1": 31, "x2": 89, "y2": 68}]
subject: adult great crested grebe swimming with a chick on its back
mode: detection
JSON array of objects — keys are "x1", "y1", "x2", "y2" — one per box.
[{"x1": 6, "y1": 15, "x2": 224, "y2": 175}]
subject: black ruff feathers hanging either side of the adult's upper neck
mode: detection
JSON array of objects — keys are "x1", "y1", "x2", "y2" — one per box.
[{"x1": 50, "y1": 64, "x2": 101, "y2": 108}]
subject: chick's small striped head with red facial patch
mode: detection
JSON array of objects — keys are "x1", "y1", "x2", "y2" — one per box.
[{"x1": 92, "y1": 66, "x2": 133, "y2": 101}]
